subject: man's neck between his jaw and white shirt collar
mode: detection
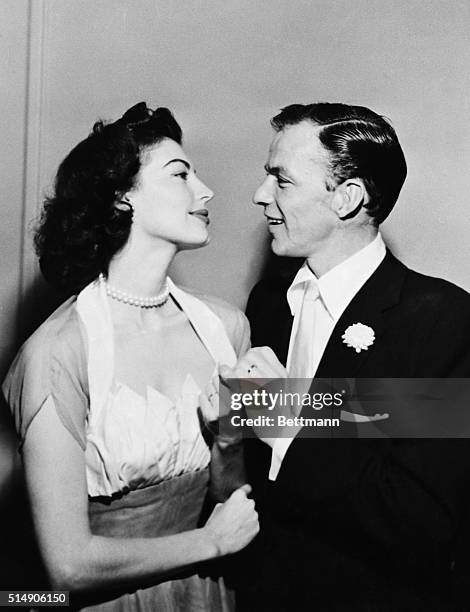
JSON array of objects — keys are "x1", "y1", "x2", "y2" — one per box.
[{"x1": 307, "y1": 226, "x2": 378, "y2": 278}]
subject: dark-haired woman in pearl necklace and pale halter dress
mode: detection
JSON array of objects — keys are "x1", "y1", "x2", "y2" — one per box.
[{"x1": 4, "y1": 103, "x2": 258, "y2": 611}]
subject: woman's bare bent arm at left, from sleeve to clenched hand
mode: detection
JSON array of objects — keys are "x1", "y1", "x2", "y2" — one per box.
[{"x1": 23, "y1": 400, "x2": 258, "y2": 590}]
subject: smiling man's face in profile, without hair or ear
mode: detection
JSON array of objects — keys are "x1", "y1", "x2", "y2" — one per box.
[{"x1": 253, "y1": 121, "x2": 338, "y2": 257}]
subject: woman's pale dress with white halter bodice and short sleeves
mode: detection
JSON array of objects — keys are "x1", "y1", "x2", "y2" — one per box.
[{"x1": 3, "y1": 280, "x2": 242, "y2": 612}]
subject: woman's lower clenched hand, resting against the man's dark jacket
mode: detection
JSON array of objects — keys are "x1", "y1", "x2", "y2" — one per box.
[{"x1": 203, "y1": 484, "x2": 259, "y2": 555}]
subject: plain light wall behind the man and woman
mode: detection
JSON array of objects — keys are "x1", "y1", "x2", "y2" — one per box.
[{"x1": 0, "y1": 0, "x2": 470, "y2": 378}]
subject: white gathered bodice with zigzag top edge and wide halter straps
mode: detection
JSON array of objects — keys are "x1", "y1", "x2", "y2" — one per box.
[{"x1": 77, "y1": 281, "x2": 236, "y2": 497}]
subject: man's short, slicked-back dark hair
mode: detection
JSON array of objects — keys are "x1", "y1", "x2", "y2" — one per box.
[{"x1": 271, "y1": 102, "x2": 406, "y2": 225}]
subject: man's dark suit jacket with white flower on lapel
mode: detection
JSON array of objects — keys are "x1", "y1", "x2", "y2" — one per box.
[{"x1": 240, "y1": 252, "x2": 470, "y2": 612}]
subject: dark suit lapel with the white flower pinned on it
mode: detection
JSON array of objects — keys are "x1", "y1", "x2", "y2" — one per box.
[{"x1": 315, "y1": 250, "x2": 406, "y2": 378}]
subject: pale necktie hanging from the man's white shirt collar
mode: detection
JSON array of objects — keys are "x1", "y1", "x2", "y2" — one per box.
[{"x1": 289, "y1": 279, "x2": 320, "y2": 378}]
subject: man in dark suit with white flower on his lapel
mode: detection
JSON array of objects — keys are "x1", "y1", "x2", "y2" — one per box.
[{"x1": 237, "y1": 103, "x2": 470, "y2": 612}]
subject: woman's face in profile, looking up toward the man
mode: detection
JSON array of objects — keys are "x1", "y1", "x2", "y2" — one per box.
[{"x1": 126, "y1": 138, "x2": 214, "y2": 249}]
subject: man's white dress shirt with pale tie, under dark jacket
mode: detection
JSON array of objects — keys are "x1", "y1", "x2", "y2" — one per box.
[{"x1": 269, "y1": 232, "x2": 386, "y2": 480}]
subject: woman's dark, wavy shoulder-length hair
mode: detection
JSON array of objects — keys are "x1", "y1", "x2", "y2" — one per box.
[{"x1": 34, "y1": 102, "x2": 182, "y2": 293}]
